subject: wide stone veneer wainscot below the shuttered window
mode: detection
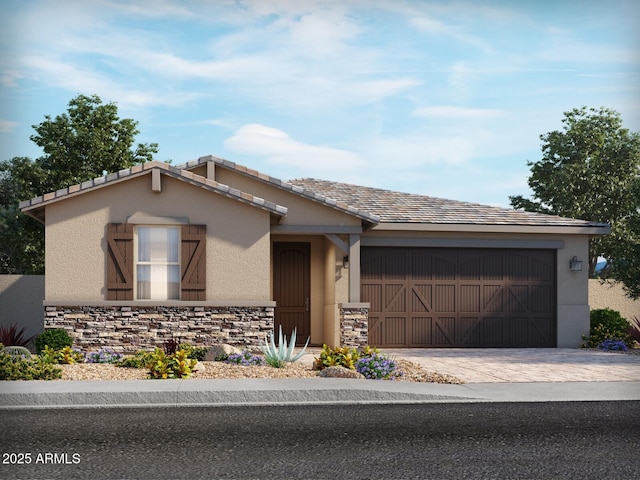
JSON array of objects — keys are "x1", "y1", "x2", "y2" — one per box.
[{"x1": 44, "y1": 306, "x2": 274, "y2": 353}]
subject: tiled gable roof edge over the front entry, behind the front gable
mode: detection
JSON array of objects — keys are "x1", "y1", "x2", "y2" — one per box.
[{"x1": 177, "y1": 155, "x2": 380, "y2": 224}]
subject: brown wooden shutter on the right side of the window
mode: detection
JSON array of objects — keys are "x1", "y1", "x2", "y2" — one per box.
[{"x1": 181, "y1": 225, "x2": 207, "y2": 301}]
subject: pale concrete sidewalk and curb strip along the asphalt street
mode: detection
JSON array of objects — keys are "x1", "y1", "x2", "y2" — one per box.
[{"x1": 0, "y1": 378, "x2": 640, "y2": 409}]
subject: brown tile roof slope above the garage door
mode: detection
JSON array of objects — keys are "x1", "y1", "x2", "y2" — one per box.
[{"x1": 288, "y1": 178, "x2": 608, "y2": 228}]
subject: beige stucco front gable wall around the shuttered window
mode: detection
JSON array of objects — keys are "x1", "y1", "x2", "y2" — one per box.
[{"x1": 45, "y1": 174, "x2": 270, "y2": 302}]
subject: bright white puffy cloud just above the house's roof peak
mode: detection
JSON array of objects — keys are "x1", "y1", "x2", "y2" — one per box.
[{"x1": 224, "y1": 123, "x2": 366, "y2": 178}]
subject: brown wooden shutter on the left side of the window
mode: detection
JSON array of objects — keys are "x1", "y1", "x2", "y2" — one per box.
[{"x1": 107, "y1": 223, "x2": 133, "y2": 300}]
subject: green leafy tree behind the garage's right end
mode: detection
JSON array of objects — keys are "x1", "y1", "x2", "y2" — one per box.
[{"x1": 509, "y1": 107, "x2": 640, "y2": 298}]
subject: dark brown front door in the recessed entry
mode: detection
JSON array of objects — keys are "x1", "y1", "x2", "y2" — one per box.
[{"x1": 273, "y1": 242, "x2": 311, "y2": 345}]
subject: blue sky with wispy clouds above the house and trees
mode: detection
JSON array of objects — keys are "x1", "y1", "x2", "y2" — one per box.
[{"x1": 0, "y1": 0, "x2": 640, "y2": 206}]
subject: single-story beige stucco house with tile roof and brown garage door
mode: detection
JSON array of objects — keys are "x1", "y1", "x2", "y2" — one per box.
[{"x1": 20, "y1": 156, "x2": 609, "y2": 352}]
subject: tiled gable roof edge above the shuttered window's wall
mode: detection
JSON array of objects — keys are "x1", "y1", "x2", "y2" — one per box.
[{"x1": 19, "y1": 161, "x2": 288, "y2": 222}]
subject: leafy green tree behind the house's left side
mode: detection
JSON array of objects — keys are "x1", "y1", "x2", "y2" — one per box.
[{"x1": 0, "y1": 95, "x2": 158, "y2": 274}]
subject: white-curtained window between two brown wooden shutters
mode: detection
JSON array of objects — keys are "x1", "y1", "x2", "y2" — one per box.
[{"x1": 135, "y1": 227, "x2": 180, "y2": 300}]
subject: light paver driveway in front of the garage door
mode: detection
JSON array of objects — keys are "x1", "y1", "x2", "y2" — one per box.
[{"x1": 381, "y1": 348, "x2": 640, "y2": 383}]
